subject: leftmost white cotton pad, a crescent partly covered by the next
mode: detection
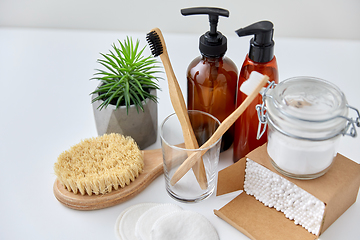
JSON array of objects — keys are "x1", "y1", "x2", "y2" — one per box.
[{"x1": 115, "y1": 203, "x2": 159, "y2": 240}]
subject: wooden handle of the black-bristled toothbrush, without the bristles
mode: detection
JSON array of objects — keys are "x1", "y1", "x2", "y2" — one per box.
[{"x1": 160, "y1": 52, "x2": 208, "y2": 190}]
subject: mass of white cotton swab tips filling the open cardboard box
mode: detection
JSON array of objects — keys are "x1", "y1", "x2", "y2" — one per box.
[{"x1": 244, "y1": 159, "x2": 325, "y2": 235}]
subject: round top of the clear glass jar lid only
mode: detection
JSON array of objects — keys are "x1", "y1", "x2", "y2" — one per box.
[{"x1": 267, "y1": 77, "x2": 348, "y2": 122}]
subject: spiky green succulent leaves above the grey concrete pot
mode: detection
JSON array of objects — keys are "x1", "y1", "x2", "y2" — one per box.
[{"x1": 91, "y1": 37, "x2": 161, "y2": 113}]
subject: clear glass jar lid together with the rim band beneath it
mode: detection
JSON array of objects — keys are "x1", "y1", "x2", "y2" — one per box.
[{"x1": 265, "y1": 77, "x2": 348, "y2": 139}]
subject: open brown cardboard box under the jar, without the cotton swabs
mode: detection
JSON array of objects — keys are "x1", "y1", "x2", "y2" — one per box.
[{"x1": 214, "y1": 145, "x2": 360, "y2": 240}]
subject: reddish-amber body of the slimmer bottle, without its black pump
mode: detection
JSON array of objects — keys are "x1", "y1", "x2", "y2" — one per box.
[{"x1": 233, "y1": 55, "x2": 279, "y2": 162}]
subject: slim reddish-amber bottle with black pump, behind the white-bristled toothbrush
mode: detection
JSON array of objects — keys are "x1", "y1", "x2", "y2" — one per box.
[{"x1": 233, "y1": 21, "x2": 278, "y2": 162}]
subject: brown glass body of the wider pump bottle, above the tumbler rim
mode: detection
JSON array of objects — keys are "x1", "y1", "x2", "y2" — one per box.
[{"x1": 187, "y1": 55, "x2": 238, "y2": 151}]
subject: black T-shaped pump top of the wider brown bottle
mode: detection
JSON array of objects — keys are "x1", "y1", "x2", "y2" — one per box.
[{"x1": 181, "y1": 7, "x2": 229, "y2": 58}]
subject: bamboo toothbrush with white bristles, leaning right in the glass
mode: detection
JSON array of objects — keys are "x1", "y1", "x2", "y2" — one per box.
[{"x1": 170, "y1": 71, "x2": 269, "y2": 185}]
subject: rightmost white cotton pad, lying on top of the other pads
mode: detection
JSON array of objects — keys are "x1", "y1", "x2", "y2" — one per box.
[{"x1": 150, "y1": 210, "x2": 220, "y2": 240}]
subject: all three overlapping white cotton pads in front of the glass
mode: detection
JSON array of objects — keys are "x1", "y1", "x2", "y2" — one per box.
[{"x1": 115, "y1": 203, "x2": 219, "y2": 240}]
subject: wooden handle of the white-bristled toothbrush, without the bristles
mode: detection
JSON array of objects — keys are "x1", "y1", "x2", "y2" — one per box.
[{"x1": 170, "y1": 76, "x2": 269, "y2": 185}]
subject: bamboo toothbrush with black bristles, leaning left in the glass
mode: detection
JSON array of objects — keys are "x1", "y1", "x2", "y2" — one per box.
[{"x1": 146, "y1": 28, "x2": 207, "y2": 190}]
